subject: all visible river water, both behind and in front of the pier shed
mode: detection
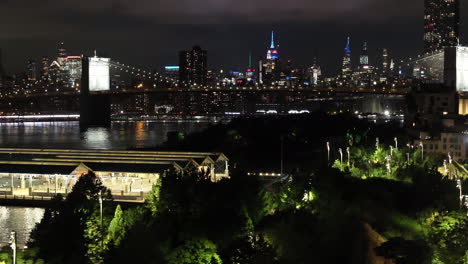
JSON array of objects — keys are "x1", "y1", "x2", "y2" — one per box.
[{"x1": 0, "y1": 121, "x2": 218, "y2": 244}]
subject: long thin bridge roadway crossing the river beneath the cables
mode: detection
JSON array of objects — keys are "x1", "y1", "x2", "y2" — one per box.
[{"x1": 0, "y1": 87, "x2": 410, "y2": 100}]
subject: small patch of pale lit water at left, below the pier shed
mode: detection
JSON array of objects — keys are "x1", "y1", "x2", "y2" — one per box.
[{"x1": 0, "y1": 206, "x2": 44, "y2": 244}]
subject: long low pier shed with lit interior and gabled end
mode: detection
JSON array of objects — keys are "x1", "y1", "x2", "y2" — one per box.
[{"x1": 0, "y1": 148, "x2": 229, "y2": 200}]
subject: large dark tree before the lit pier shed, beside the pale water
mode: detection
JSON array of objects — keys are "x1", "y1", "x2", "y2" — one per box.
[{"x1": 30, "y1": 172, "x2": 112, "y2": 264}]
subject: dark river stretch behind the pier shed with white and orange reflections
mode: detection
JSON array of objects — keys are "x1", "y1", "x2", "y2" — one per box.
[{"x1": 0, "y1": 121, "x2": 212, "y2": 150}]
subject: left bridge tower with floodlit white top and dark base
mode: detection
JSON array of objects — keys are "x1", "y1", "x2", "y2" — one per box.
[{"x1": 80, "y1": 55, "x2": 111, "y2": 127}]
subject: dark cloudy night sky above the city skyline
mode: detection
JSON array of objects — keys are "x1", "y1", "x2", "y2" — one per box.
[{"x1": 0, "y1": 0, "x2": 468, "y2": 75}]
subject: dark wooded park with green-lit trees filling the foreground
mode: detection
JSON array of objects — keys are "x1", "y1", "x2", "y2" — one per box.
[{"x1": 0, "y1": 113, "x2": 468, "y2": 264}]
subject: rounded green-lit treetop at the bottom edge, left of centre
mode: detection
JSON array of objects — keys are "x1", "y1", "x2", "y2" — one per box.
[{"x1": 167, "y1": 239, "x2": 222, "y2": 264}]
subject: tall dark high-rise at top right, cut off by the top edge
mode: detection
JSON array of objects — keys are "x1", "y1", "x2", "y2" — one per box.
[{"x1": 424, "y1": 0, "x2": 460, "y2": 53}]
